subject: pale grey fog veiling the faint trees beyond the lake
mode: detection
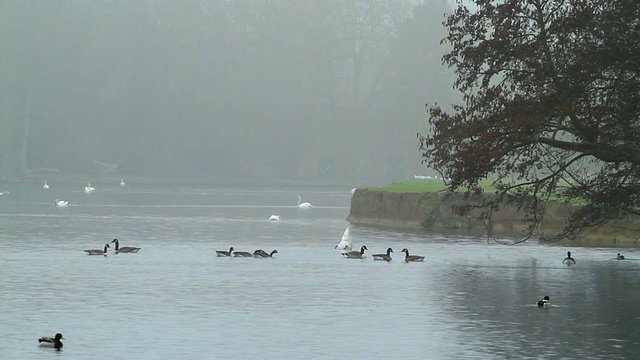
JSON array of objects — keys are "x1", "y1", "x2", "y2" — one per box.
[{"x1": 0, "y1": 0, "x2": 456, "y2": 186}]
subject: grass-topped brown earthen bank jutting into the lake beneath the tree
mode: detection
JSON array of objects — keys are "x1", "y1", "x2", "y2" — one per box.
[{"x1": 347, "y1": 189, "x2": 640, "y2": 247}]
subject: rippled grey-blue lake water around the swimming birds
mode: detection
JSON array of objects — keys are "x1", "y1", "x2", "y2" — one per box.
[{"x1": 0, "y1": 182, "x2": 640, "y2": 360}]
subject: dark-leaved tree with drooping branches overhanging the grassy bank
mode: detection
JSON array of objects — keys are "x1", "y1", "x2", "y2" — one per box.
[{"x1": 418, "y1": 0, "x2": 640, "y2": 241}]
